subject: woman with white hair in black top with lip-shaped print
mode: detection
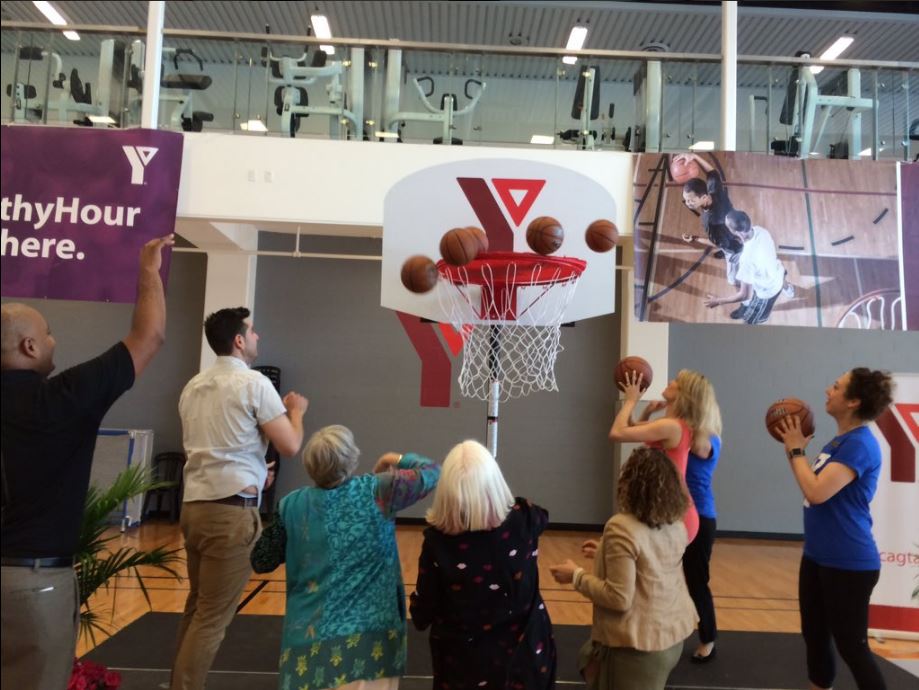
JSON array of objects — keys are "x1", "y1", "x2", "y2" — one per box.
[{"x1": 410, "y1": 441, "x2": 556, "y2": 690}]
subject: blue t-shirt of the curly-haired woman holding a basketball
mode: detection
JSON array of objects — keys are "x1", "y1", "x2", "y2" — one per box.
[{"x1": 804, "y1": 426, "x2": 881, "y2": 570}]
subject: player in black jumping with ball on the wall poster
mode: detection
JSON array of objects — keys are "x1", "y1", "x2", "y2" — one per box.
[{"x1": 674, "y1": 153, "x2": 743, "y2": 285}]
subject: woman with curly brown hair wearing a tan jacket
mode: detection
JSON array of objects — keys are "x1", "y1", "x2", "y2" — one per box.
[{"x1": 551, "y1": 448, "x2": 698, "y2": 690}]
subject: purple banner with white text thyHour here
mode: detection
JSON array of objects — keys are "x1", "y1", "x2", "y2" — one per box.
[{"x1": 0, "y1": 126, "x2": 183, "y2": 302}]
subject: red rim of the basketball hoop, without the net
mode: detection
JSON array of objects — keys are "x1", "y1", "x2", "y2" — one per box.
[{"x1": 437, "y1": 252, "x2": 587, "y2": 287}]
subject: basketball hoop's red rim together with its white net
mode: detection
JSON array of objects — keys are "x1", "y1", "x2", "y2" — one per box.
[{"x1": 437, "y1": 252, "x2": 587, "y2": 402}]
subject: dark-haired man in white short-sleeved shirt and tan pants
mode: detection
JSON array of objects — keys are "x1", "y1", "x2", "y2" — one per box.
[{"x1": 171, "y1": 307, "x2": 308, "y2": 690}]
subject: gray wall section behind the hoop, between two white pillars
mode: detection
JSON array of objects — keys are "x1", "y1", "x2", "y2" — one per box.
[{"x1": 255, "y1": 233, "x2": 619, "y2": 524}]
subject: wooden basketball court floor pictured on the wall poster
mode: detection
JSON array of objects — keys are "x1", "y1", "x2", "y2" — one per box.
[{"x1": 634, "y1": 154, "x2": 899, "y2": 327}]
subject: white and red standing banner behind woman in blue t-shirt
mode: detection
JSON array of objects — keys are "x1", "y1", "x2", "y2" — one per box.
[{"x1": 868, "y1": 374, "x2": 919, "y2": 637}]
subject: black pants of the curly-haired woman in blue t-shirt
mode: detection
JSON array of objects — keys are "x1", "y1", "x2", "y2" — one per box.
[{"x1": 798, "y1": 556, "x2": 887, "y2": 690}]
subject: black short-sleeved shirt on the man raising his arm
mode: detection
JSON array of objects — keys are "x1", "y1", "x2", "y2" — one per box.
[{"x1": 2, "y1": 343, "x2": 134, "y2": 558}]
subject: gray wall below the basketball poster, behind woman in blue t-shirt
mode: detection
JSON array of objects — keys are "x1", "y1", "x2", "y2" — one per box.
[{"x1": 669, "y1": 324, "x2": 919, "y2": 534}]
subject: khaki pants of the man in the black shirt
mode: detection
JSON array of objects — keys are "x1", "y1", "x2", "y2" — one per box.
[{"x1": 0, "y1": 566, "x2": 80, "y2": 690}]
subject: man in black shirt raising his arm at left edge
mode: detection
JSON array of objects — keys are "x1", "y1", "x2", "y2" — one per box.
[{"x1": 0, "y1": 235, "x2": 173, "y2": 690}]
